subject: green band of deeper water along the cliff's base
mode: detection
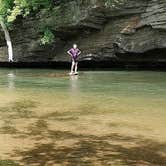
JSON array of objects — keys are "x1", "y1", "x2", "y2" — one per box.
[{"x1": 0, "y1": 69, "x2": 166, "y2": 94}]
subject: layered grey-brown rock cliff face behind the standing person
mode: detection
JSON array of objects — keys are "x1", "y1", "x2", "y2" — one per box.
[{"x1": 0, "y1": 0, "x2": 166, "y2": 62}]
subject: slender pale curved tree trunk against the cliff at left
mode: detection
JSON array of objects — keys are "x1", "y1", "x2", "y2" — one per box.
[{"x1": 0, "y1": 20, "x2": 13, "y2": 62}]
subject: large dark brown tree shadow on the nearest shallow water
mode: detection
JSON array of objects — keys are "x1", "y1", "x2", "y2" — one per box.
[{"x1": 11, "y1": 131, "x2": 166, "y2": 166}]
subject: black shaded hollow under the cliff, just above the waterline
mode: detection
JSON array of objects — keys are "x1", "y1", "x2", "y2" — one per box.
[{"x1": 0, "y1": 48, "x2": 166, "y2": 70}]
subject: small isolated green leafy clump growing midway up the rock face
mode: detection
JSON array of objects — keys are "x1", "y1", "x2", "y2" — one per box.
[{"x1": 41, "y1": 27, "x2": 55, "y2": 45}]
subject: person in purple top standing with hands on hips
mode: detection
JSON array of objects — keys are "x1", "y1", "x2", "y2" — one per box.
[{"x1": 67, "y1": 44, "x2": 81, "y2": 75}]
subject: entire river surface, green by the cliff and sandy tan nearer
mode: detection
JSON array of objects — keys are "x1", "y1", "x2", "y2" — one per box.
[{"x1": 0, "y1": 69, "x2": 166, "y2": 165}]
